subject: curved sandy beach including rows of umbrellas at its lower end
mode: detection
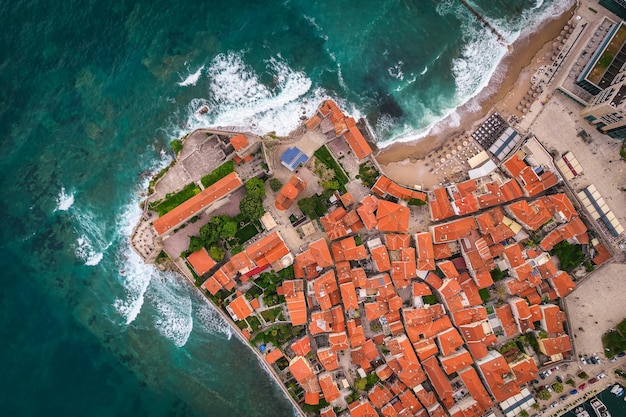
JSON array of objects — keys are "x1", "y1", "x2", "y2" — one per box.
[{"x1": 376, "y1": 5, "x2": 576, "y2": 188}]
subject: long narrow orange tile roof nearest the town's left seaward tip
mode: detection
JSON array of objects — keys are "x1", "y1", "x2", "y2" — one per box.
[{"x1": 152, "y1": 172, "x2": 243, "y2": 236}]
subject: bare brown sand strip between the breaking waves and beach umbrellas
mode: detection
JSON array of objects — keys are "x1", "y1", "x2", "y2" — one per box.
[{"x1": 375, "y1": 3, "x2": 579, "y2": 179}]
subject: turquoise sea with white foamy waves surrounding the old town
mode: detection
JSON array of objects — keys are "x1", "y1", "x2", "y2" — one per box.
[{"x1": 0, "y1": 0, "x2": 569, "y2": 416}]
